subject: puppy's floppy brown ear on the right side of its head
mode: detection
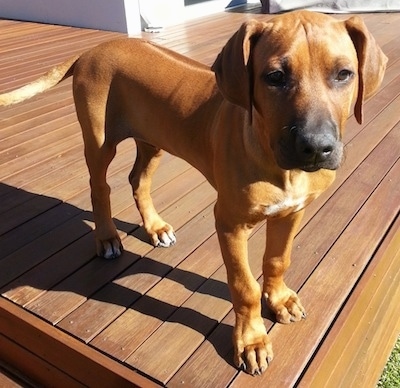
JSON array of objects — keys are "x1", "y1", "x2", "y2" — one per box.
[{"x1": 345, "y1": 16, "x2": 388, "y2": 124}]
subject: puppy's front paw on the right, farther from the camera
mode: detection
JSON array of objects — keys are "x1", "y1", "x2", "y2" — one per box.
[{"x1": 264, "y1": 284, "x2": 306, "y2": 324}]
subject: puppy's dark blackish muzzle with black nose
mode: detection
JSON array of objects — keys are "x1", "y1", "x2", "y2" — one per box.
[{"x1": 276, "y1": 120, "x2": 343, "y2": 172}]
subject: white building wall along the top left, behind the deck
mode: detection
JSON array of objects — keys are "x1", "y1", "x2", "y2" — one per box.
[{"x1": 0, "y1": 0, "x2": 258, "y2": 35}]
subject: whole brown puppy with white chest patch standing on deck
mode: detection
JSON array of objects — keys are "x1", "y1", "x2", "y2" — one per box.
[{"x1": 0, "y1": 12, "x2": 387, "y2": 374}]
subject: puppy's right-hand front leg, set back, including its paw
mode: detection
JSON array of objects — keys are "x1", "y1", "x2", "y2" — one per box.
[{"x1": 263, "y1": 210, "x2": 305, "y2": 323}]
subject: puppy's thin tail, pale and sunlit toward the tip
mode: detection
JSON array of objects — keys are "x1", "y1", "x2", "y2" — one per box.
[{"x1": 0, "y1": 55, "x2": 80, "y2": 106}]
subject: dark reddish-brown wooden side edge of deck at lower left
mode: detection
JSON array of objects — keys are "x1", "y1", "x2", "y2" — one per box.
[{"x1": 0, "y1": 298, "x2": 157, "y2": 387}]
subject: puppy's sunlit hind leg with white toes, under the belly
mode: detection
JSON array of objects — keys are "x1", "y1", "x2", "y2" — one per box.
[{"x1": 129, "y1": 140, "x2": 176, "y2": 247}]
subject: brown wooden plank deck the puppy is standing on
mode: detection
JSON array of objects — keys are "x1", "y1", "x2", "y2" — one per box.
[{"x1": 0, "y1": 6, "x2": 400, "y2": 387}]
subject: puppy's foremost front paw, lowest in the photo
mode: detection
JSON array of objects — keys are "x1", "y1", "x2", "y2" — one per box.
[{"x1": 233, "y1": 318, "x2": 274, "y2": 376}]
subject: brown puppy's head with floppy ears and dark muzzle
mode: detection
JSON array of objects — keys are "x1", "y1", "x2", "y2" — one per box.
[{"x1": 212, "y1": 11, "x2": 387, "y2": 171}]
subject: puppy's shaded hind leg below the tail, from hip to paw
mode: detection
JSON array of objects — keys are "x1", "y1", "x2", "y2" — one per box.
[{"x1": 73, "y1": 76, "x2": 122, "y2": 259}]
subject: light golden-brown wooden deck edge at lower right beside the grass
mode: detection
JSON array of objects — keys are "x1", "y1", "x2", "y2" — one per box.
[{"x1": 297, "y1": 217, "x2": 400, "y2": 387}]
